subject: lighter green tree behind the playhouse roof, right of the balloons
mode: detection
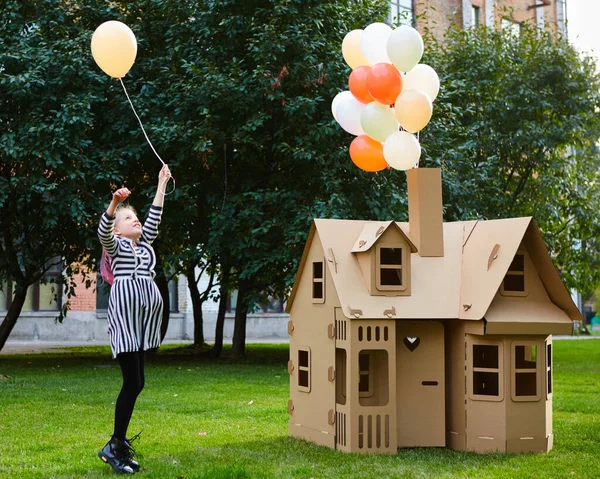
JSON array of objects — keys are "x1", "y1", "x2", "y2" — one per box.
[{"x1": 421, "y1": 25, "x2": 600, "y2": 291}]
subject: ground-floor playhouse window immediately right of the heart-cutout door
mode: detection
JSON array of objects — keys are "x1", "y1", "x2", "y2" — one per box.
[{"x1": 469, "y1": 342, "x2": 504, "y2": 401}]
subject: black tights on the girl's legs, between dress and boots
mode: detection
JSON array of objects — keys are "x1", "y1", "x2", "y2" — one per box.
[{"x1": 113, "y1": 351, "x2": 146, "y2": 441}]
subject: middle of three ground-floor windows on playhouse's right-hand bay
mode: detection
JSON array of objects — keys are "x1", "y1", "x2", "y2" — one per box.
[{"x1": 511, "y1": 342, "x2": 540, "y2": 401}]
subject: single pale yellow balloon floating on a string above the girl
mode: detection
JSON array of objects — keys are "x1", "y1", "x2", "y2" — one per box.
[{"x1": 92, "y1": 20, "x2": 137, "y2": 78}]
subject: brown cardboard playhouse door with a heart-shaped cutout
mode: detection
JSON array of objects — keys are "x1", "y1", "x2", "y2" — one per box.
[{"x1": 396, "y1": 320, "x2": 446, "y2": 447}]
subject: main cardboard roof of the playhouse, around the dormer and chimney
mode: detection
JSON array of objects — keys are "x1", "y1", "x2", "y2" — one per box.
[{"x1": 286, "y1": 217, "x2": 581, "y2": 321}]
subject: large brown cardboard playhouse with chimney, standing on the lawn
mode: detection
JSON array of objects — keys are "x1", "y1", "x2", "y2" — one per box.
[{"x1": 287, "y1": 168, "x2": 581, "y2": 454}]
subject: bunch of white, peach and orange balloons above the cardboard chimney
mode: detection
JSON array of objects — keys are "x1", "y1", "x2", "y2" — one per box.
[{"x1": 331, "y1": 23, "x2": 440, "y2": 171}]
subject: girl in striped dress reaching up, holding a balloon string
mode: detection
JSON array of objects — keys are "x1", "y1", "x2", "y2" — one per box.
[{"x1": 98, "y1": 165, "x2": 171, "y2": 474}]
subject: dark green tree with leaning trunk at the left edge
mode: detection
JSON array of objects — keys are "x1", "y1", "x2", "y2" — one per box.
[{"x1": 0, "y1": 1, "x2": 124, "y2": 349}]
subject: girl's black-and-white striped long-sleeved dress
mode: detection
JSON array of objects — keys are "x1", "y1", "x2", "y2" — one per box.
[{"x1": 98, "y1": 205, "x2": 163, "y2": 358}]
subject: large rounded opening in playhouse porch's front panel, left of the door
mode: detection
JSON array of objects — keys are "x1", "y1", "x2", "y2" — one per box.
[{"x1": 358, "y1": 349, "x2": 389, "y2": 406}]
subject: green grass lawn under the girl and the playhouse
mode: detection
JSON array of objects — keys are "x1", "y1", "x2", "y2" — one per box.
[{"x1": 0, "y1": 339, "x2": 600, "y2": 479}]
